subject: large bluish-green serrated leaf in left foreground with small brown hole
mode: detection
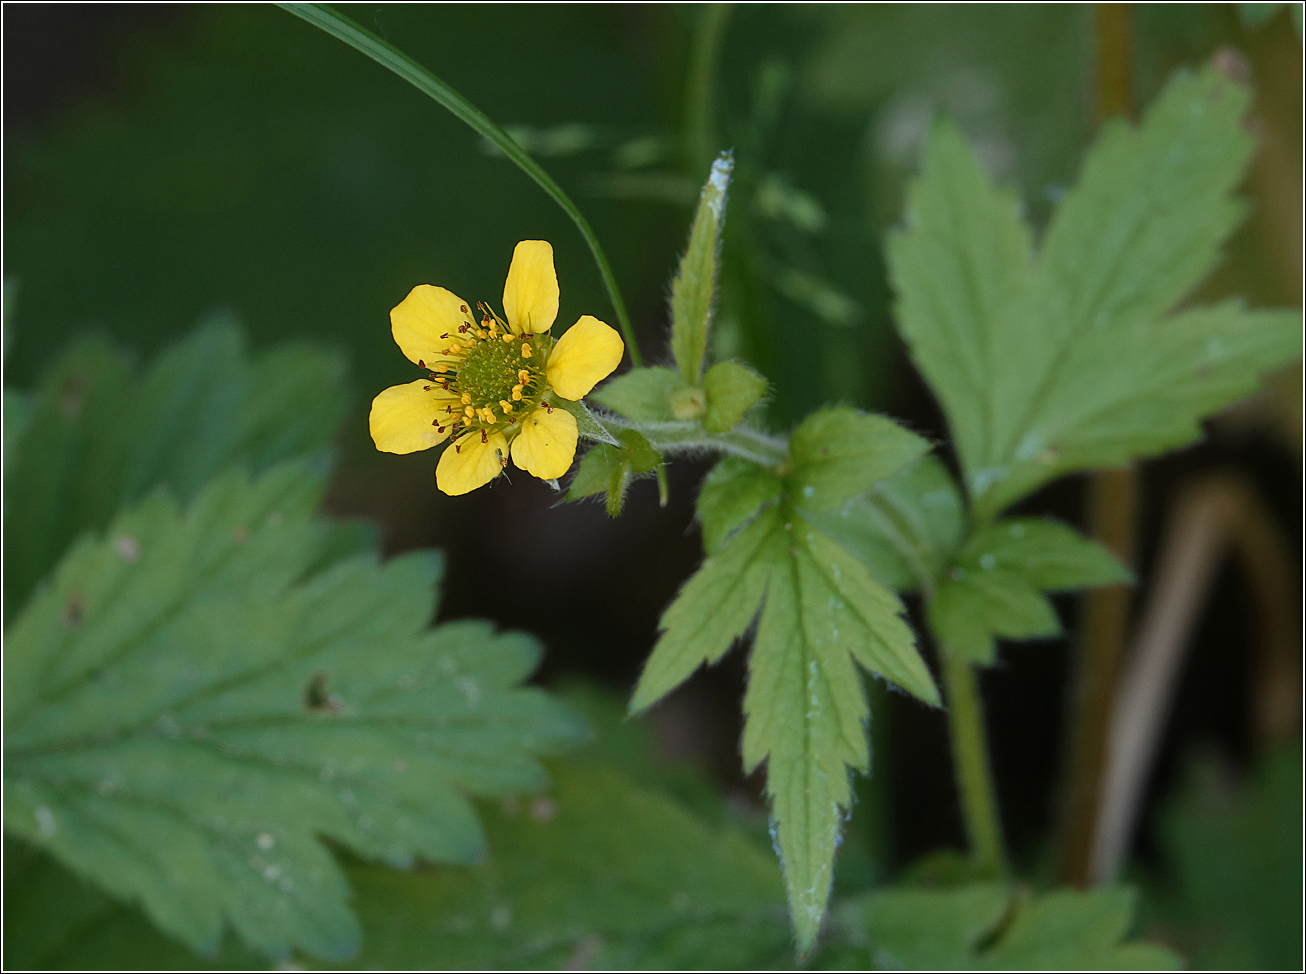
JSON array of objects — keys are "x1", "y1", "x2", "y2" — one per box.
[{"x1": 4, "y1": 463, "x2": 579, "y2": 957}]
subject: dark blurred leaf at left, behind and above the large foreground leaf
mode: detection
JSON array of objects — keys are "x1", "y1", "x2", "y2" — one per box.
[{"x1": 4, "y1": 316, "x2": 345, "y2": 619}]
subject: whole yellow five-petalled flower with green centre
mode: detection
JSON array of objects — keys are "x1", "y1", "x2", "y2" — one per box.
[{"x1": 368, "y1": 240, "x2": 626, "y2": 494}]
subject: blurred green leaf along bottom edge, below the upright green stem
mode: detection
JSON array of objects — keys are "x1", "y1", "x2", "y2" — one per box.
[{"x1": 838, "y1": 883, "x2": 1179, "y2": 970}]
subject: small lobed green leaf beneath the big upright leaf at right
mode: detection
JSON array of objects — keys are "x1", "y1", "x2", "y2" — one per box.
[{"x1": 929, "y1": 517, "x2": 1134, "y2": 666}]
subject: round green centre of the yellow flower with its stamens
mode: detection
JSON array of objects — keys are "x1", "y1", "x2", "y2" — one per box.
[{"x1": 453, "y1": 334, "x2": 550, "y2": 426}]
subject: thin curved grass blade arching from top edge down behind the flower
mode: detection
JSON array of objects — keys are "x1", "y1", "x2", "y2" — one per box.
[{"x1": 277, "y1": 4, "x2": 644, "y2": 368}]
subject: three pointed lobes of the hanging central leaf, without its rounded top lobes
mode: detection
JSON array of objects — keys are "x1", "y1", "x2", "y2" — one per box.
[{"x1": 631, "y1": 501, "x2": 939, "y2": 953}]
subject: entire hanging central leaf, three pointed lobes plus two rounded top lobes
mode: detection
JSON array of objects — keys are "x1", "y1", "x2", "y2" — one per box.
[{"x1": 631, "y1": 409, "x2": 939, "y2": 953}]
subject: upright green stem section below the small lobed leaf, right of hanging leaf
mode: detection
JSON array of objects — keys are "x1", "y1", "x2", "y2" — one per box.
[{"x1": 939, "y1": 644, "x2": 1007, "y2": 879}]
